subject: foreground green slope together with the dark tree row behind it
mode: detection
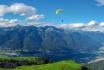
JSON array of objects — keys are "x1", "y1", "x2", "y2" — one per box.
[{"x1": 0, "y1": 57, "x2": 88, "y2": 70}]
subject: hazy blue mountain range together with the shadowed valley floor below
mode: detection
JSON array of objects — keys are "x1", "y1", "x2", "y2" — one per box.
[{"x1": 0, "y1": 25, "x2": 104, "y2": 62}]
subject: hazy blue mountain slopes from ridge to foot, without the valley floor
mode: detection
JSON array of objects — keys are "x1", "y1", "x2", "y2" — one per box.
[{"x1": 0, "y1": 26, "x2": 104, "y2": 52}]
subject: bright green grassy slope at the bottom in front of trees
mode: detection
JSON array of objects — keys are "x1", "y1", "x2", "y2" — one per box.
[{"x1": 14, "y1": 61, "x2": 81, "y2": 70}]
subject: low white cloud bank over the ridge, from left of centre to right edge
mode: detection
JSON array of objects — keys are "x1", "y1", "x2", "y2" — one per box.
[{"x1": 23, "y1": 20, "x2": 104, "y2": 32}]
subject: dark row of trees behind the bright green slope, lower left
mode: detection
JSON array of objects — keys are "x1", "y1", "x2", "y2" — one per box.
[{"x1": 0, "y1": 57, "x2": 50, "y2": 68}]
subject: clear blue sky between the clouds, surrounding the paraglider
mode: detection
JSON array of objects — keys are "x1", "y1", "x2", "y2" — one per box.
[{"x1": 0, "y1": 0, "x2": 104, "y2": 23}]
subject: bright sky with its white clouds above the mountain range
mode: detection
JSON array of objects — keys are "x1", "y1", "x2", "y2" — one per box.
[{"x1": 0, "y1": 0, "x2": 104, "y2": 26}]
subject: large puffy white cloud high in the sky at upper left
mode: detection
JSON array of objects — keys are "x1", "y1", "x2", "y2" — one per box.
[{"x1": 0, "y1": 3, "x2": 44, "y2": 20}]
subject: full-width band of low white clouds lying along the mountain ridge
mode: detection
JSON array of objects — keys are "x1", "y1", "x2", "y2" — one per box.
[{"x1": 0, "y1": 18, "x2": 104, "y2": 32}]
